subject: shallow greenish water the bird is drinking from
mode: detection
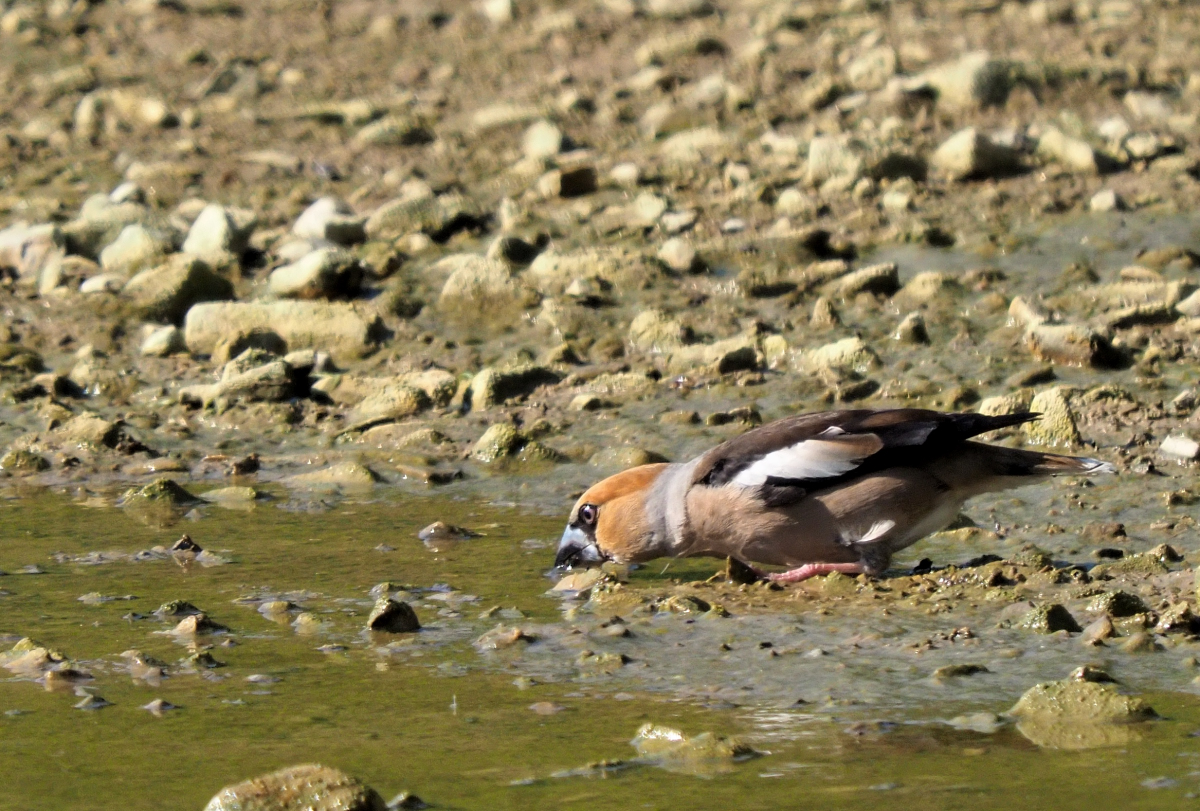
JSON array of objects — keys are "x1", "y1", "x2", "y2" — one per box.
[{"x1": 7, "y1": 491, "x2": 1200, "y2": 810}]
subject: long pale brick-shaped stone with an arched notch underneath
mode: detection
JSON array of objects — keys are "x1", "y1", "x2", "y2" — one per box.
[{"x1": 184, "y1": 301, "x2": 383, "y2": 359}]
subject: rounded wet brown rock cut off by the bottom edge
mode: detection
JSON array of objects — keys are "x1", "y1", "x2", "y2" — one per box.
[{"x1": 204, "y1": 763, "x2": 388, "y2": 811}]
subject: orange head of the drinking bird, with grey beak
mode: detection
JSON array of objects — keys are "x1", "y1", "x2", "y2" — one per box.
[{"x1": 554, "y1": 464, "x2": 667, "y2": 569}]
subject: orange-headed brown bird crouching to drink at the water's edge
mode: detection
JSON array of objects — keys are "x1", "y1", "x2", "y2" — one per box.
[{"x1": 554, "y1": 408, "x2": 1115, "y2": 583}]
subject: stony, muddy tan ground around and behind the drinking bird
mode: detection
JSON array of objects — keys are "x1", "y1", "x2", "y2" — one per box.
[{"x1": 0, "y1": 0, "x2": 1200, "y2": 807}]
